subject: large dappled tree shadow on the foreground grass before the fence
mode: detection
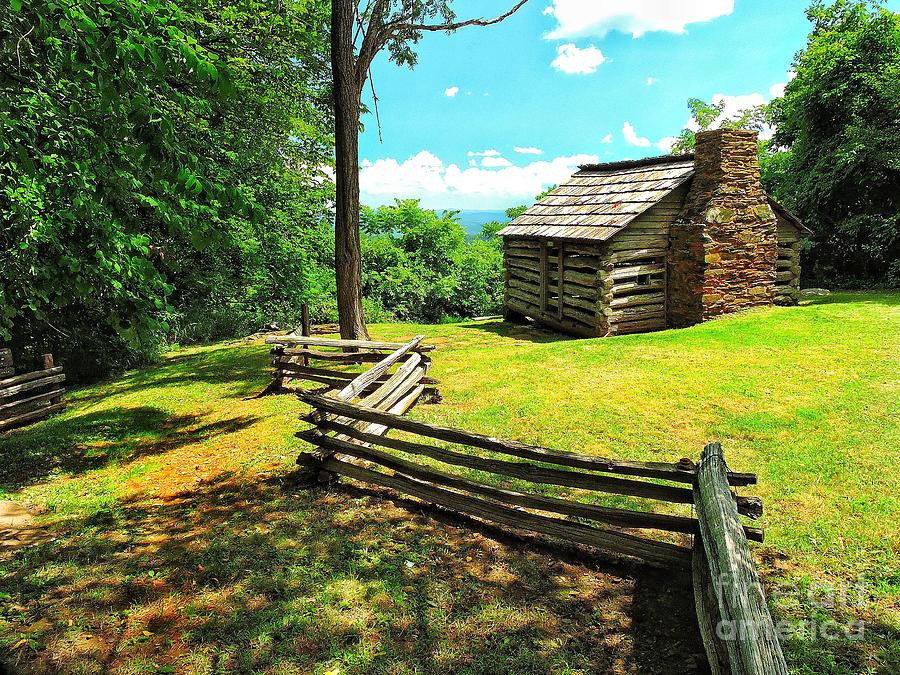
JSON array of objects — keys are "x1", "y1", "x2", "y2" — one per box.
[{"x1": 0, "y1": 472, "x2": 703, "y2": 674}]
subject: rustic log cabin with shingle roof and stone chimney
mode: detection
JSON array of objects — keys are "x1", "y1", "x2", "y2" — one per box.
[{"x1": 499, "y1": 129, "x2": 806, "y2": 337}]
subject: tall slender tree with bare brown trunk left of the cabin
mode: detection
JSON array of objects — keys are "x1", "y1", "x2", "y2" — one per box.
[{"x1": 331, "y1": 0, "x2": 528, "y2": 339}]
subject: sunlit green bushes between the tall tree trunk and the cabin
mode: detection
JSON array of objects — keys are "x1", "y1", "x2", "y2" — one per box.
[{"x1": 360, "y1": 199, "x2": 503, "y2": 322}]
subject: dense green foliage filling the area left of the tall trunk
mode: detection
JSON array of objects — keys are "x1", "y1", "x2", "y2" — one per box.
[{"x1": 0, "y1": 0, "x2": 330, "y2": 373}]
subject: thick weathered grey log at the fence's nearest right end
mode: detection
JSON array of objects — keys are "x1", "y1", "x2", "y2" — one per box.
[{"x1": 694, "y1": 443, "x2": 788, "y2": 675}]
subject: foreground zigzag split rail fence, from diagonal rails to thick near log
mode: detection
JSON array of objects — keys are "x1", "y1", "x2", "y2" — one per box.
[{"x1": 297, "y1": 360, "x2": 787, "y2": 675}]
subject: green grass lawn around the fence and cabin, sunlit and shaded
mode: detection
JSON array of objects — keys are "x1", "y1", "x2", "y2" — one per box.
[{"x1": 0, "y1": 294, "x2": 900, "y2": 674}]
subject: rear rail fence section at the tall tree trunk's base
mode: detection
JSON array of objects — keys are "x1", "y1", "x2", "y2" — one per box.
[{"x1": 266, "y1": 335, "x2": 437, "y2": 396}]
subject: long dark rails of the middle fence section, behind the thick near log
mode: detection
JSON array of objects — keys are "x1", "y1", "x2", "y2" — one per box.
[{"x1": 298, "y1": 393, "x2": 763, "y2": 568}]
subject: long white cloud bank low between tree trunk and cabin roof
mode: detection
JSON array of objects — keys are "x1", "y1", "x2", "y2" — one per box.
[{"x1": 359, "y1": 150, "x2": 599, "y2": 209}]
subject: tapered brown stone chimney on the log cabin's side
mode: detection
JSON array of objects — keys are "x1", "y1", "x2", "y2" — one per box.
[{"x1": 668, "y1": 129, "x2": 778, "y2": 327}]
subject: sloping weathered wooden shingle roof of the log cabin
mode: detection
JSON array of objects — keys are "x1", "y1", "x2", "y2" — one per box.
[{"x1": 499, "y1": 155, "x2": 694, "y2": 241}]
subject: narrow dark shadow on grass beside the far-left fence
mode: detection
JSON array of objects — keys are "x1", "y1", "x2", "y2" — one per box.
[{"x1": 0, "y1": 406, "x2": 258, "y2": 490}]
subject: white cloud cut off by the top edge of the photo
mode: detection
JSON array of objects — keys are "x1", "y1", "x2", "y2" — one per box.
[{"x1": 544, "y1": 0, "x2": 734, "y2": 40}]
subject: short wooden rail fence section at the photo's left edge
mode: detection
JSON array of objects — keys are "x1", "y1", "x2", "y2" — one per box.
[{"x1": 0, "y1": 350, "x2": 66, "y2": 431}]
